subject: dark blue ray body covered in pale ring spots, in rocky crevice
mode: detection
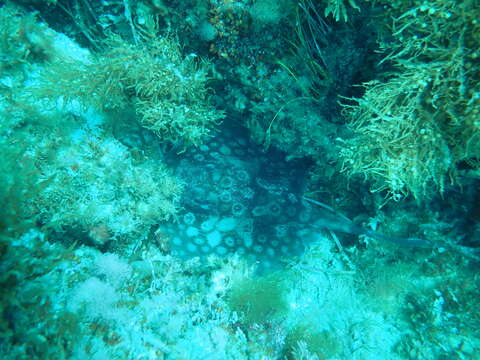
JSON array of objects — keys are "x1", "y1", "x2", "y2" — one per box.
[{"x1": 164, "y1": 125, "x2": 318, "y2": 267}]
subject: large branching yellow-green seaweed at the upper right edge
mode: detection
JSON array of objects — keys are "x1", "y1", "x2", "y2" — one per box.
[{"x1": 340, "y1": 0, "x2": 480, "y2": 201}]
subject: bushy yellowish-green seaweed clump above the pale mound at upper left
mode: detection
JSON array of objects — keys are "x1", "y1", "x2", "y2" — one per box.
[{"x1": 37, "y1": 35, "x2": 223, "y2": 147}]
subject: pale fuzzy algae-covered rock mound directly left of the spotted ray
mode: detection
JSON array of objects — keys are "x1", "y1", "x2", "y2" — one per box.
[{"x1": 34, "y1": 124, "x2": 182, "y2": 246}]
